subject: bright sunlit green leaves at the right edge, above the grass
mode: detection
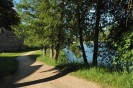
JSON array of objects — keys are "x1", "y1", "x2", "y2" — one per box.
[{"x1": 117, "y1": 28, "x2": 133, "y2": 60}]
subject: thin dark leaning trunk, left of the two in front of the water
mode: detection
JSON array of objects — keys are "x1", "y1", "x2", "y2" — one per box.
[{"x1": 78, "y1": 4, "x2": 88, "y2": 64}]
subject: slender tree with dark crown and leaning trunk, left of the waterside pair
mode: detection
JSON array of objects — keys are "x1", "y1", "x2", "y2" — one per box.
[{"x1": 62, "y1": 0, "x2": 92, "y2": 64}]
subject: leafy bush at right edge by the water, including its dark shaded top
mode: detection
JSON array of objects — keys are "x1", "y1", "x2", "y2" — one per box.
[{"x1": 108, "y1": 23, "x2": 133, "y2": 73}]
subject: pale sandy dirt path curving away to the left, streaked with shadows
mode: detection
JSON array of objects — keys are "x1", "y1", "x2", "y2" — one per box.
[{"x1": 1, "y1": 51, "x2": 100, "y2": 88}]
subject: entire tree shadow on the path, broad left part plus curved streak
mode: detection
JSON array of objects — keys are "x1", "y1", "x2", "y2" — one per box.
[{"x1": 0, "y1": 55, "x2": 76, "y2": 88}]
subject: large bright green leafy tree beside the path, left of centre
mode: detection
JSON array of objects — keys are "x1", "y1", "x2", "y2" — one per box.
[{"x1": 17, "y1": 0, "x2": 68, "y2": 60}]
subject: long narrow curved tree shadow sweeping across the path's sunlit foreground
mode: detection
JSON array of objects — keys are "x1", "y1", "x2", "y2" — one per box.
[{"x1": 12, "y1": 64, "x2": 79, "y2": 88}]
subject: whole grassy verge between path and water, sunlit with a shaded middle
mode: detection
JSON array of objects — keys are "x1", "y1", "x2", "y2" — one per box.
[{"x1": 35, "y1": 52, "x2": 133, "y2": 88}]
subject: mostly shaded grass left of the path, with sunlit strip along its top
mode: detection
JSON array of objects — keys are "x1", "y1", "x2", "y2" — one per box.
[{"x1": 0, "y1": 52, "x2": 33, "y2": 78}]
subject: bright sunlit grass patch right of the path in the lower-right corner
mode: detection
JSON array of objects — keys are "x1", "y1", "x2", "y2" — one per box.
[{"x1": 71, "y1": 67, "x2": 133, "y2": 88}]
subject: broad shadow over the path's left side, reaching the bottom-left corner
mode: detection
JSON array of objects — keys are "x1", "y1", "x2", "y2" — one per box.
[{"x1": 0, "y1": 55, "x2": 42, "y2": 88}]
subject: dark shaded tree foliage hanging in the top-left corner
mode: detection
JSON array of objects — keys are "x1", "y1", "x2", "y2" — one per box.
[{"x1": 0, "y1": 0, "x2": 20, "y2": 30}]
